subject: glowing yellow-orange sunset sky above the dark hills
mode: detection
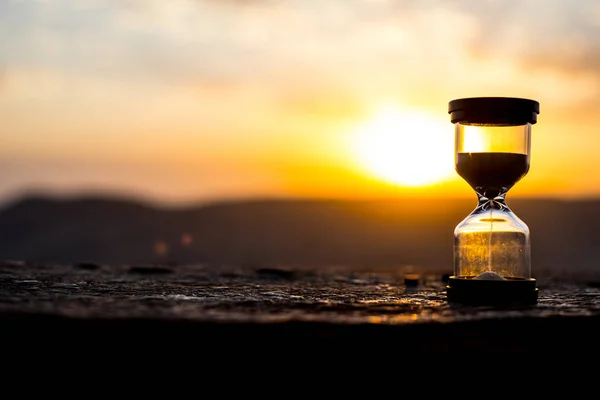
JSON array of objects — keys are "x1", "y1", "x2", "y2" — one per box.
[{"x1": 0, "y1": 0, "x2": 600, "y2": 204}]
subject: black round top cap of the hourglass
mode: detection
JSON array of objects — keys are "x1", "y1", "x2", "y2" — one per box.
[{"x1": 448, "y1": 97, "x2": 540, "y2": 125}]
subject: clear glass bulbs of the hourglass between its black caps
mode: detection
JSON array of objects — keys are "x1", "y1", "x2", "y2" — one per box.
[{"x1": 454, "y1": 123, "x2": 531, "y2": 280}]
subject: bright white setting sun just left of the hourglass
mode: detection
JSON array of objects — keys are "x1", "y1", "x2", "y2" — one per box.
[{"x1": 353, "y1": 106, "x2": 455, "y2": 187}]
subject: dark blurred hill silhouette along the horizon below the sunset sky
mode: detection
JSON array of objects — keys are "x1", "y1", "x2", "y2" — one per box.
[{"x1": 0, "y1": 197, "x2": 600, "y2": 277}]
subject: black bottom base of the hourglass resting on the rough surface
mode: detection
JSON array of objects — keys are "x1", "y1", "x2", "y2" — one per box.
[{"x1": 446, "y1": 276, "x2": 538, "y2": 306}]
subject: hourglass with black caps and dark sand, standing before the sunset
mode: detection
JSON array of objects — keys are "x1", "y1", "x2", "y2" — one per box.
[{"x1": 446, "y1": 97, "x2": 540, "y2": 304}]
